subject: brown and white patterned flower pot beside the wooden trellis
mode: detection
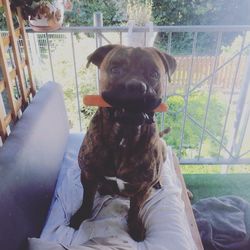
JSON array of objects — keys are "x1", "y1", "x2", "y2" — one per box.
[{"x1": 29, "y1": 0, "x2": 64, "y2": 32}]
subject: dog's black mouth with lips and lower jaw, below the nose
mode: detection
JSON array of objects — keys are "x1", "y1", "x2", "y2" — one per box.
[{"x1": 102, "y1": 91, "x2": 161, "y2": 126}]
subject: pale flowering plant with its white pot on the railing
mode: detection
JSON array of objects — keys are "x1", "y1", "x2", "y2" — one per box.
[{"x1": 123, "y1": 0, "x2": 157, "y2": 47}]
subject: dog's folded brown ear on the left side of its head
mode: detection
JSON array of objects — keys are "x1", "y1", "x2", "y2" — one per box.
[{"x1": 87, "y1": 44, "x2": 120, "y2": 68}]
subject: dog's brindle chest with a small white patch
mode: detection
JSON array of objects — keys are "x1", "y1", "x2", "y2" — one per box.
[{"x1": 86, "y1": 109, "x2": 157, "y2": 196}]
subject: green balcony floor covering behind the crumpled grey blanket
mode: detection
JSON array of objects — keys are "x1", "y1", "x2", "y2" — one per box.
[{"x1": 184, "y1": 174, "x2": 250, "y2": 203}]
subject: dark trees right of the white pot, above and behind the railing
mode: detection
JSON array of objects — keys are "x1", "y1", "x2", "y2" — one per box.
[{"x1": 153, "y1": 0, "x2": 250, "y2": 55}]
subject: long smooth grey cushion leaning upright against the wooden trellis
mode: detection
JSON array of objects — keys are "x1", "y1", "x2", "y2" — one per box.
[{"x1": 0, "y1": 82, "x2": 69, "y2": 250}]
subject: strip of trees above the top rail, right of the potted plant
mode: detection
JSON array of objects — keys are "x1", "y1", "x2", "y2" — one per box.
[{"x1": 153, "y1": 0, "x2": 250, "y2": 25}]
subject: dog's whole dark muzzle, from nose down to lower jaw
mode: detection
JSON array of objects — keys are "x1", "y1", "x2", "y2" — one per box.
[{"x1": 102, "y1": 79, "x2": 161, "y2": 126}]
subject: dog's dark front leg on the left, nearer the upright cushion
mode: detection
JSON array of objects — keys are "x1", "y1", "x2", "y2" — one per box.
[{"x1": 70, "y1": 174, "x2": 97, "y2": 229}]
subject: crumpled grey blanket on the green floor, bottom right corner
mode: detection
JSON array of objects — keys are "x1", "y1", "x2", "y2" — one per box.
[{"x1": 193, "y1": 195, "x2": 250, "y2": 250}]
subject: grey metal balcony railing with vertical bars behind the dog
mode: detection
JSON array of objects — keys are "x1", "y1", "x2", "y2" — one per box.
[{"x1": 25, "y1": 19, "x2": 250, "y2": 164}]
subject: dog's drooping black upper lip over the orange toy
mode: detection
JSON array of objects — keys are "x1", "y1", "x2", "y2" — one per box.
[{"x1": 102, "y1": 91, "x2": 161, "y2": 112}]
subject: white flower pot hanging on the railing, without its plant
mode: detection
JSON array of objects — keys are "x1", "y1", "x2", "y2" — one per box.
[{"x1": 122, "y1": 21, "x2": 157, "y2": 47}]
